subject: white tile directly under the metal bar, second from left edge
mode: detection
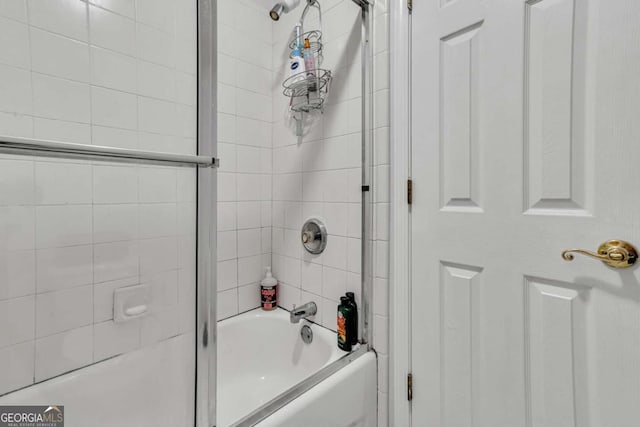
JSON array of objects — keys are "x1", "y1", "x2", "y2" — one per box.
[{"x1": 35, "y1": 162, "x2": 92, "y2": 205}]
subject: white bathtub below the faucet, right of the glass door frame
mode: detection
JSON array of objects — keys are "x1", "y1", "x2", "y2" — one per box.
[{"x1": 216, "y1": 309, "x2": 376, "y2": 427}]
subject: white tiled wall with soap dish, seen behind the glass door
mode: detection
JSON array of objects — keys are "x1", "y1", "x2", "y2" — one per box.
[{"x1": 0, "y1": 0, "x2": 197, "y2": 394}]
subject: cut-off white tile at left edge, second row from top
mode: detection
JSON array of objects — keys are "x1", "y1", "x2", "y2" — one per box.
[{"x1": 0, "y1": 16, "x2": 31, "y2": 69}]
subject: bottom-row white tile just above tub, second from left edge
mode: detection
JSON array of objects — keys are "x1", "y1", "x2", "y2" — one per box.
[{"x1": 35, "y1": 325, "x2": 93, "y2": 381}]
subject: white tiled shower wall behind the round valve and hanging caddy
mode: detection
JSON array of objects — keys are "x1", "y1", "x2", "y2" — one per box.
[{"x1": 273, "y1": 0, "x2": 362, "y2": 330}]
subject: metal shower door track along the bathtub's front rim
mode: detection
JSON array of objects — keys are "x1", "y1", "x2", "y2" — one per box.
[{"x1": 229, "y1": 344, "x2": 370, "y2": 427}]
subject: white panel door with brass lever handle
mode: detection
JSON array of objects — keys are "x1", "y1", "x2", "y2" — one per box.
[{"x1": 411, "y1": 0, "x2": 640, "y2": 427}]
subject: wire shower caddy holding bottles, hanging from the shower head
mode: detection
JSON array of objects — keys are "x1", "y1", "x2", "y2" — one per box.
[{"x1": 282, "y1": 0, "x2": 331, "y2": 136}]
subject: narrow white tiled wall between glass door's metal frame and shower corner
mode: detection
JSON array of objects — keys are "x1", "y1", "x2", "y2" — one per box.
[{"x1": 217, "y1": 0, "x2": 272, "y2": 319}]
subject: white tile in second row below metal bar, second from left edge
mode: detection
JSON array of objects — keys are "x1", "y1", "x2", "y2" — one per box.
[{"x1": 36, "y1": 205, "x2": 93, "y2": 249}]
